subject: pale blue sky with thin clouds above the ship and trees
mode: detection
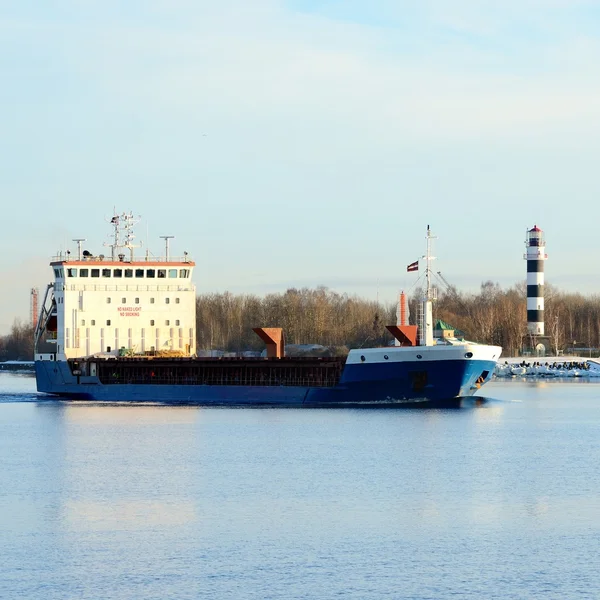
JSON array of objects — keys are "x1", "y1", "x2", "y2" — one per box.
[{"x1": 0, "y1": 0, "x2": 600, "y2": 333}]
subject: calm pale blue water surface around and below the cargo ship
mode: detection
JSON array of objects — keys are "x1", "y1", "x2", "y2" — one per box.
[{"x1": 0, "y1": 373, "x2": 600, "y2": 600}]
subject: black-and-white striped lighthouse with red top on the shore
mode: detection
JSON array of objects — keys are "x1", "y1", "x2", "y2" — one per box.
[{"x1": 523, "y1": 225, "x2": 548, "y2": 335}]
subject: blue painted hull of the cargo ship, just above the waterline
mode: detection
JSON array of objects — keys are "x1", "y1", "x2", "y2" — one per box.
[{"x1": 35, "y1": 357, "x2": 496, "y2": 408}]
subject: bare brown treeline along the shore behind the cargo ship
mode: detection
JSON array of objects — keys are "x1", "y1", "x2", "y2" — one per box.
[{"x1": 0, "y1": 281, "x2": 600, "y2": 360}]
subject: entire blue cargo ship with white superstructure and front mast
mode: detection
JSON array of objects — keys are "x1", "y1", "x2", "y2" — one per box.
[{"x1": 35, "y1": 213, "x2": 501, "y2": 407}]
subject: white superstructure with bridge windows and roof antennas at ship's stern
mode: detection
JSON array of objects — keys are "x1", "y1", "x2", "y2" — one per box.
[{"x1": 35, "y1": 213, "x2": 196, "y2": 360}]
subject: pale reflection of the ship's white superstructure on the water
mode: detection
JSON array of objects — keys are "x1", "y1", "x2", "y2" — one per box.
[{"x1": 29, "y1": 402, "x2": 201, "y2": 534}]
